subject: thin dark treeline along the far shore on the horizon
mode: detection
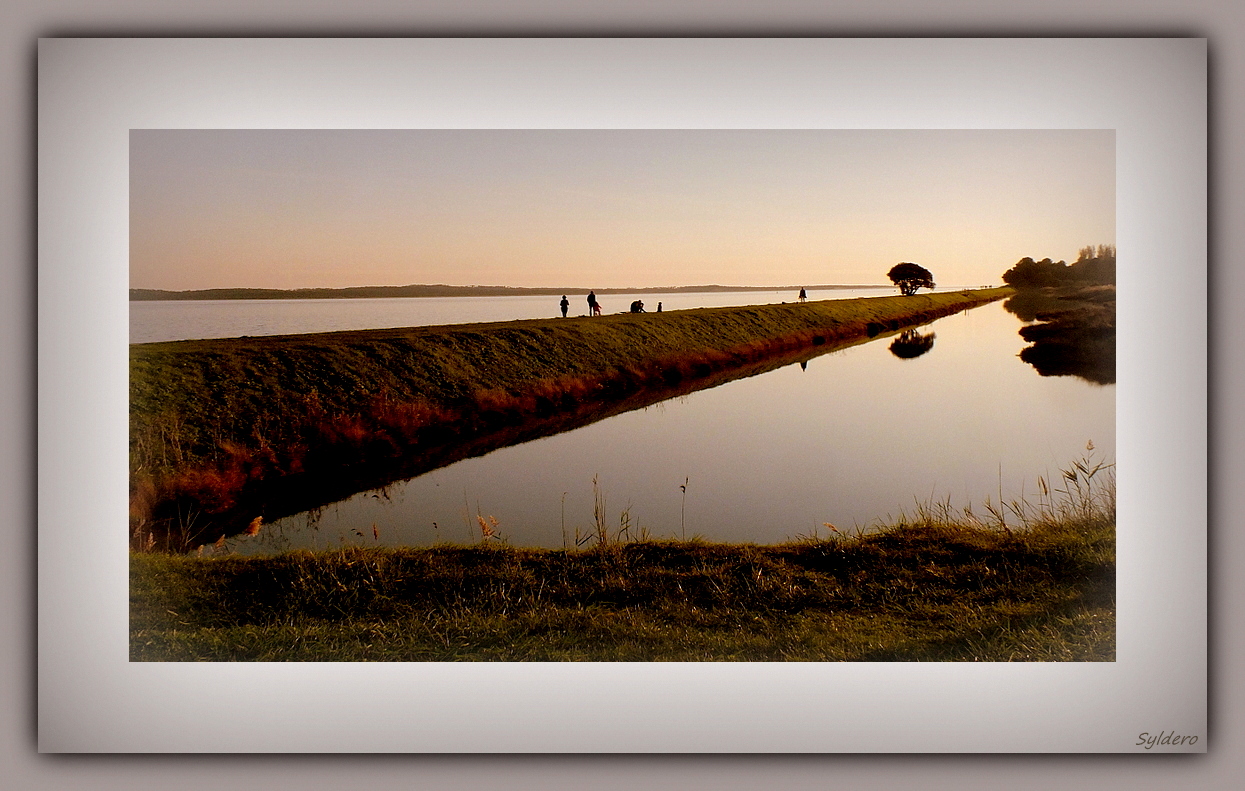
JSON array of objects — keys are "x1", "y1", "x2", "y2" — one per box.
[{"x1": 129, "y1": 284, "x2": 883, "y2": 301}]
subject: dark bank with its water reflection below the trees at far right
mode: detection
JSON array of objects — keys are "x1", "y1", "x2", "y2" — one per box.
[{"x1": 1003, "y1": 285, "x2": 1116, "y2": 385}]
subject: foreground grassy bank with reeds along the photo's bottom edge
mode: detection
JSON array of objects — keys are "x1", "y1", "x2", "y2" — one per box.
[{"x1": 131, "y1": 445, "x2": 1116, "y2": 661}]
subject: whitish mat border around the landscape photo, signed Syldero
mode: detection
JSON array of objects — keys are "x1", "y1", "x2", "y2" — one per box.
[{"x1": 39, "y1": 39, "x2": 1208, "y2": 752}]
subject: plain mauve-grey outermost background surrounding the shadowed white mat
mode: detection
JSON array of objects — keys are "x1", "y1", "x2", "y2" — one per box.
[{"x1": 0, "y1": 2, "x2": 1243, "y2": 789}]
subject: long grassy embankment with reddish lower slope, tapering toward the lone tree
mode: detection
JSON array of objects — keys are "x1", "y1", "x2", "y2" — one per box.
[{"x1": 131, "y1": 288, "x2": 1012, "y2": 549}]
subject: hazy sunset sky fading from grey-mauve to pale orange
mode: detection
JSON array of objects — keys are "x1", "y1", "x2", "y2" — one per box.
[{"x1": 129, "y1": 130, "x2": 1116, "y2": 290}]
